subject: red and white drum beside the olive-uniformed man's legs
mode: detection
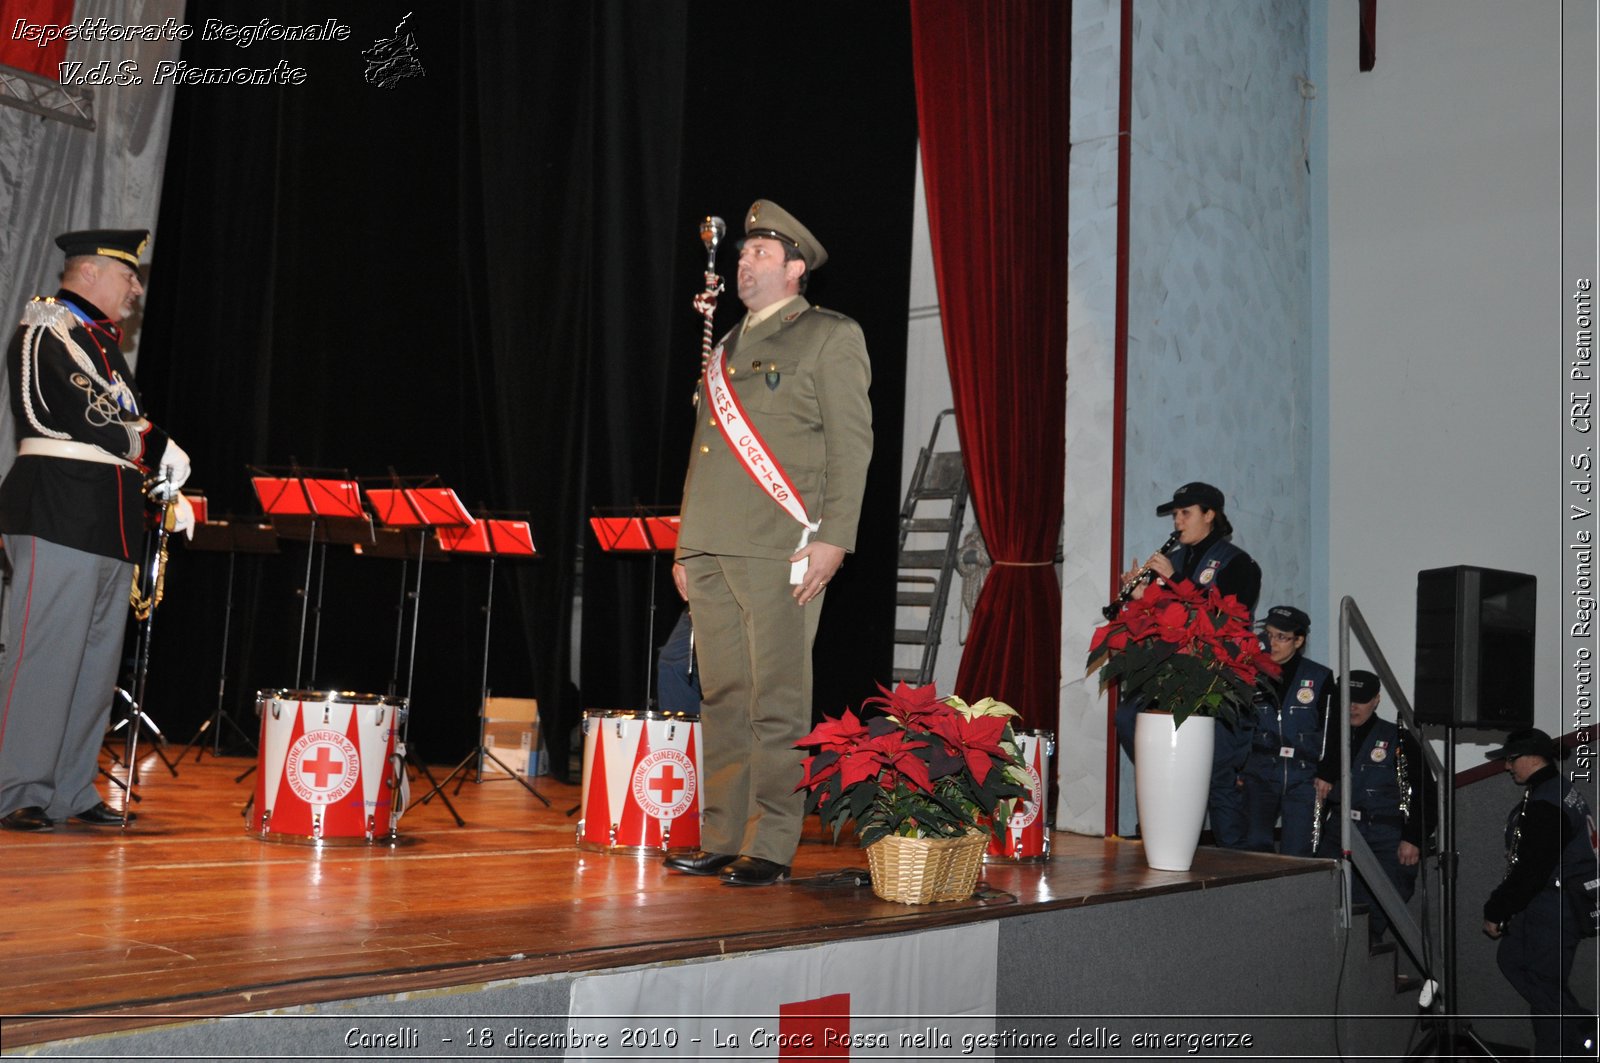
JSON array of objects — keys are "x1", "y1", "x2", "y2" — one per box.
[{"x1": 578, "y1": 712, "x2": 701, "y2": 855}]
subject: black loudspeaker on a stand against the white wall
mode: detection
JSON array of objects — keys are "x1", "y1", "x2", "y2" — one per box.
[{"x1": 1411, "y1": 565, "x2": 1539, "y2": 730}]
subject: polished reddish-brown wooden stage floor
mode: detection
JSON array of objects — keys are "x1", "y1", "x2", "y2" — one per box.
[{"x1": 0, "y1": 757, "x2": 1322, "y2": 1050}]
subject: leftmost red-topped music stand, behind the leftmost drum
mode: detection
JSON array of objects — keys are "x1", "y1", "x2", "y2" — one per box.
[{"x1": 250, "y1": 467, "x2": 373, "y2": 690}]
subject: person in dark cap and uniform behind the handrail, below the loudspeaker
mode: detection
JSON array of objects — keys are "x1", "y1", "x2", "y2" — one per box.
[{"x1": 1315, "y1": 669, "x2": 1438, "y2": 945}]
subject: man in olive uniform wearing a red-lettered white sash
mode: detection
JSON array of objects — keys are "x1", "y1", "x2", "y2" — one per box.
[{"x1": 666, "y1": 200, "x2": 872, "y2": 885}]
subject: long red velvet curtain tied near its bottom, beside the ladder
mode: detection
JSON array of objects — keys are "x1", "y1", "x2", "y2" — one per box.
[{"x1": 910, "y1": 0, "x2": 1072, "y2": 730}]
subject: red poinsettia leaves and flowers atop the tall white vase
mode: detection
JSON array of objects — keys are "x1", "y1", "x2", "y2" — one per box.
[{"x1": 1088, "y1": 580, "x2": 1282, "y2": 725}]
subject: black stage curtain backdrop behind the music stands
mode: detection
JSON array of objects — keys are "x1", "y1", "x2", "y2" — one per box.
[{"x1": 139, "y1": 0, "x2": 915, "y2": 773}]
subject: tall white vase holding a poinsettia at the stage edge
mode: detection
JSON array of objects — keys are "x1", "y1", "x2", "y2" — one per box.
[{"x1": 1133, "y1": 712, "x2": 1216, "y2": 871}]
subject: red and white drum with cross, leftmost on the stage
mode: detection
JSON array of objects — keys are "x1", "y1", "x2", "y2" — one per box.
[{"x1": 245, "y1": 690, "x2": 406, "y2": 842}]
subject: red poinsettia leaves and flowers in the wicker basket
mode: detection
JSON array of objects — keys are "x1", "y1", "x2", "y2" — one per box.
[{"x1": 795, "y1": 682, "x2": 1029, "y2": 847}]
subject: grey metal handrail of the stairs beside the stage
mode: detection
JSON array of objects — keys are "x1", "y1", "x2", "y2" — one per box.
[{"x1": 1339, "y1": 596, "x2": 1454, "y2": 991}]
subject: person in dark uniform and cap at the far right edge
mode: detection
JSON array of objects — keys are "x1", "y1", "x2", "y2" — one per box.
[{"x1": 1483, "y1": 727, "x2": 1595, "y2": 1060}]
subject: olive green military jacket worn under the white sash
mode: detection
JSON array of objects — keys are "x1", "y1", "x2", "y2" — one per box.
[{"x1": 677, "y1": 298, "x2": 872, "y2": 560}]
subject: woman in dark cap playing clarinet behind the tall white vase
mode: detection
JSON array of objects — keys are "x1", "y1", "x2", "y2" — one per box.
[{"x1": 1117, "y1": 482, "x2": 1261, "y2": 848}]
